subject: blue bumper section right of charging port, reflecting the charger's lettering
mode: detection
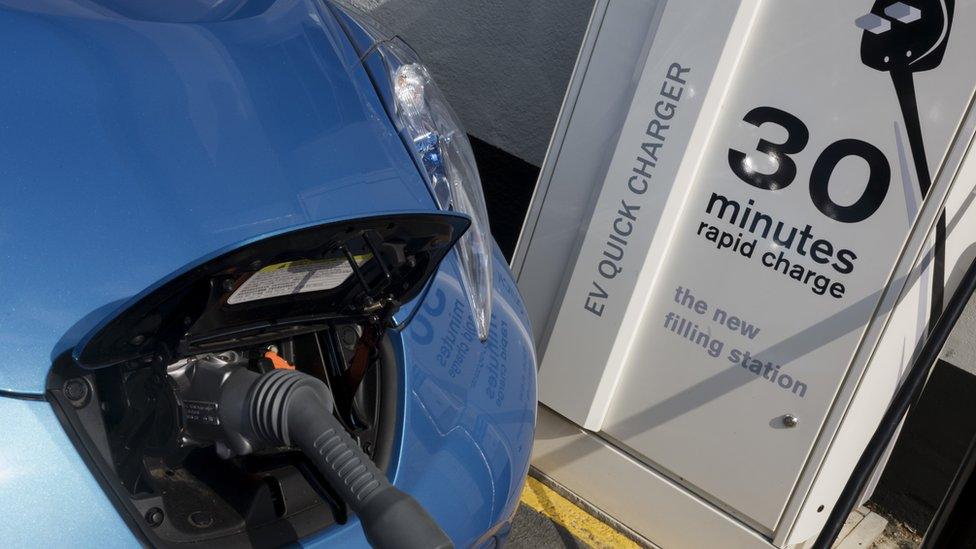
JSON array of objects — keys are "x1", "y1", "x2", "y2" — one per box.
[{"x1": 398, "y1": 254, "x2": 535, "y2": 546}]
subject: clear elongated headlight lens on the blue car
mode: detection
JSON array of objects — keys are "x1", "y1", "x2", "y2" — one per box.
[{"x1": 379, "y1": 39, "x2": 492, "y2": 341}]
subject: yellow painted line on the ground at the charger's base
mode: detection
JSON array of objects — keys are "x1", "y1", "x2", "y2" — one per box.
[{"x1": 522, "y1": 477, "x2": 640, "y2": 549}]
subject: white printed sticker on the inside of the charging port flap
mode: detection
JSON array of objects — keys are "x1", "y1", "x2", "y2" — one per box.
[{"x1": 227, "y1": 254, "x2": 372, "y2": 305}]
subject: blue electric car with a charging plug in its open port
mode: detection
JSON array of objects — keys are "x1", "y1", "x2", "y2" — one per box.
[{"x1": 0, "y1": 0, "x2": 536, "y2": 547}]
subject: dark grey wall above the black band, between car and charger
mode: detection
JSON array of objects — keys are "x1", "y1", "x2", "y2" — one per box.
[{"x1": 343, "y1": 0, "x2": 593, "y2": 166}]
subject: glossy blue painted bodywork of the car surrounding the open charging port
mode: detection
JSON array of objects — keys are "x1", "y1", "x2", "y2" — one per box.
[{"x1": 0, "y1": 0, "x2": 536, "y2": 547}]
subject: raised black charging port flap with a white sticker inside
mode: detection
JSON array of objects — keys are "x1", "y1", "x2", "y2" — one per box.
[{"x1": 74, "y1": 213, "x2": 470, "y2": 368}]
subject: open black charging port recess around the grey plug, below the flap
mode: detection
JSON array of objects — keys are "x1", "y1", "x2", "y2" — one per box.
[{"x1": 50, "y1": 323, "x2": 397, "y2": 546}]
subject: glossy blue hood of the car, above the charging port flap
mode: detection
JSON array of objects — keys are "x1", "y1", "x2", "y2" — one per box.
[{"x1": 0, "y1": 0, "x2": 433, "y2": 393}]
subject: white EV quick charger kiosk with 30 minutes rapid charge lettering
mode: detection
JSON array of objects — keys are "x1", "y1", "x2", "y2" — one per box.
[{"x1": 513, "y1": 0, "x2": 976, "y2": 547}]
